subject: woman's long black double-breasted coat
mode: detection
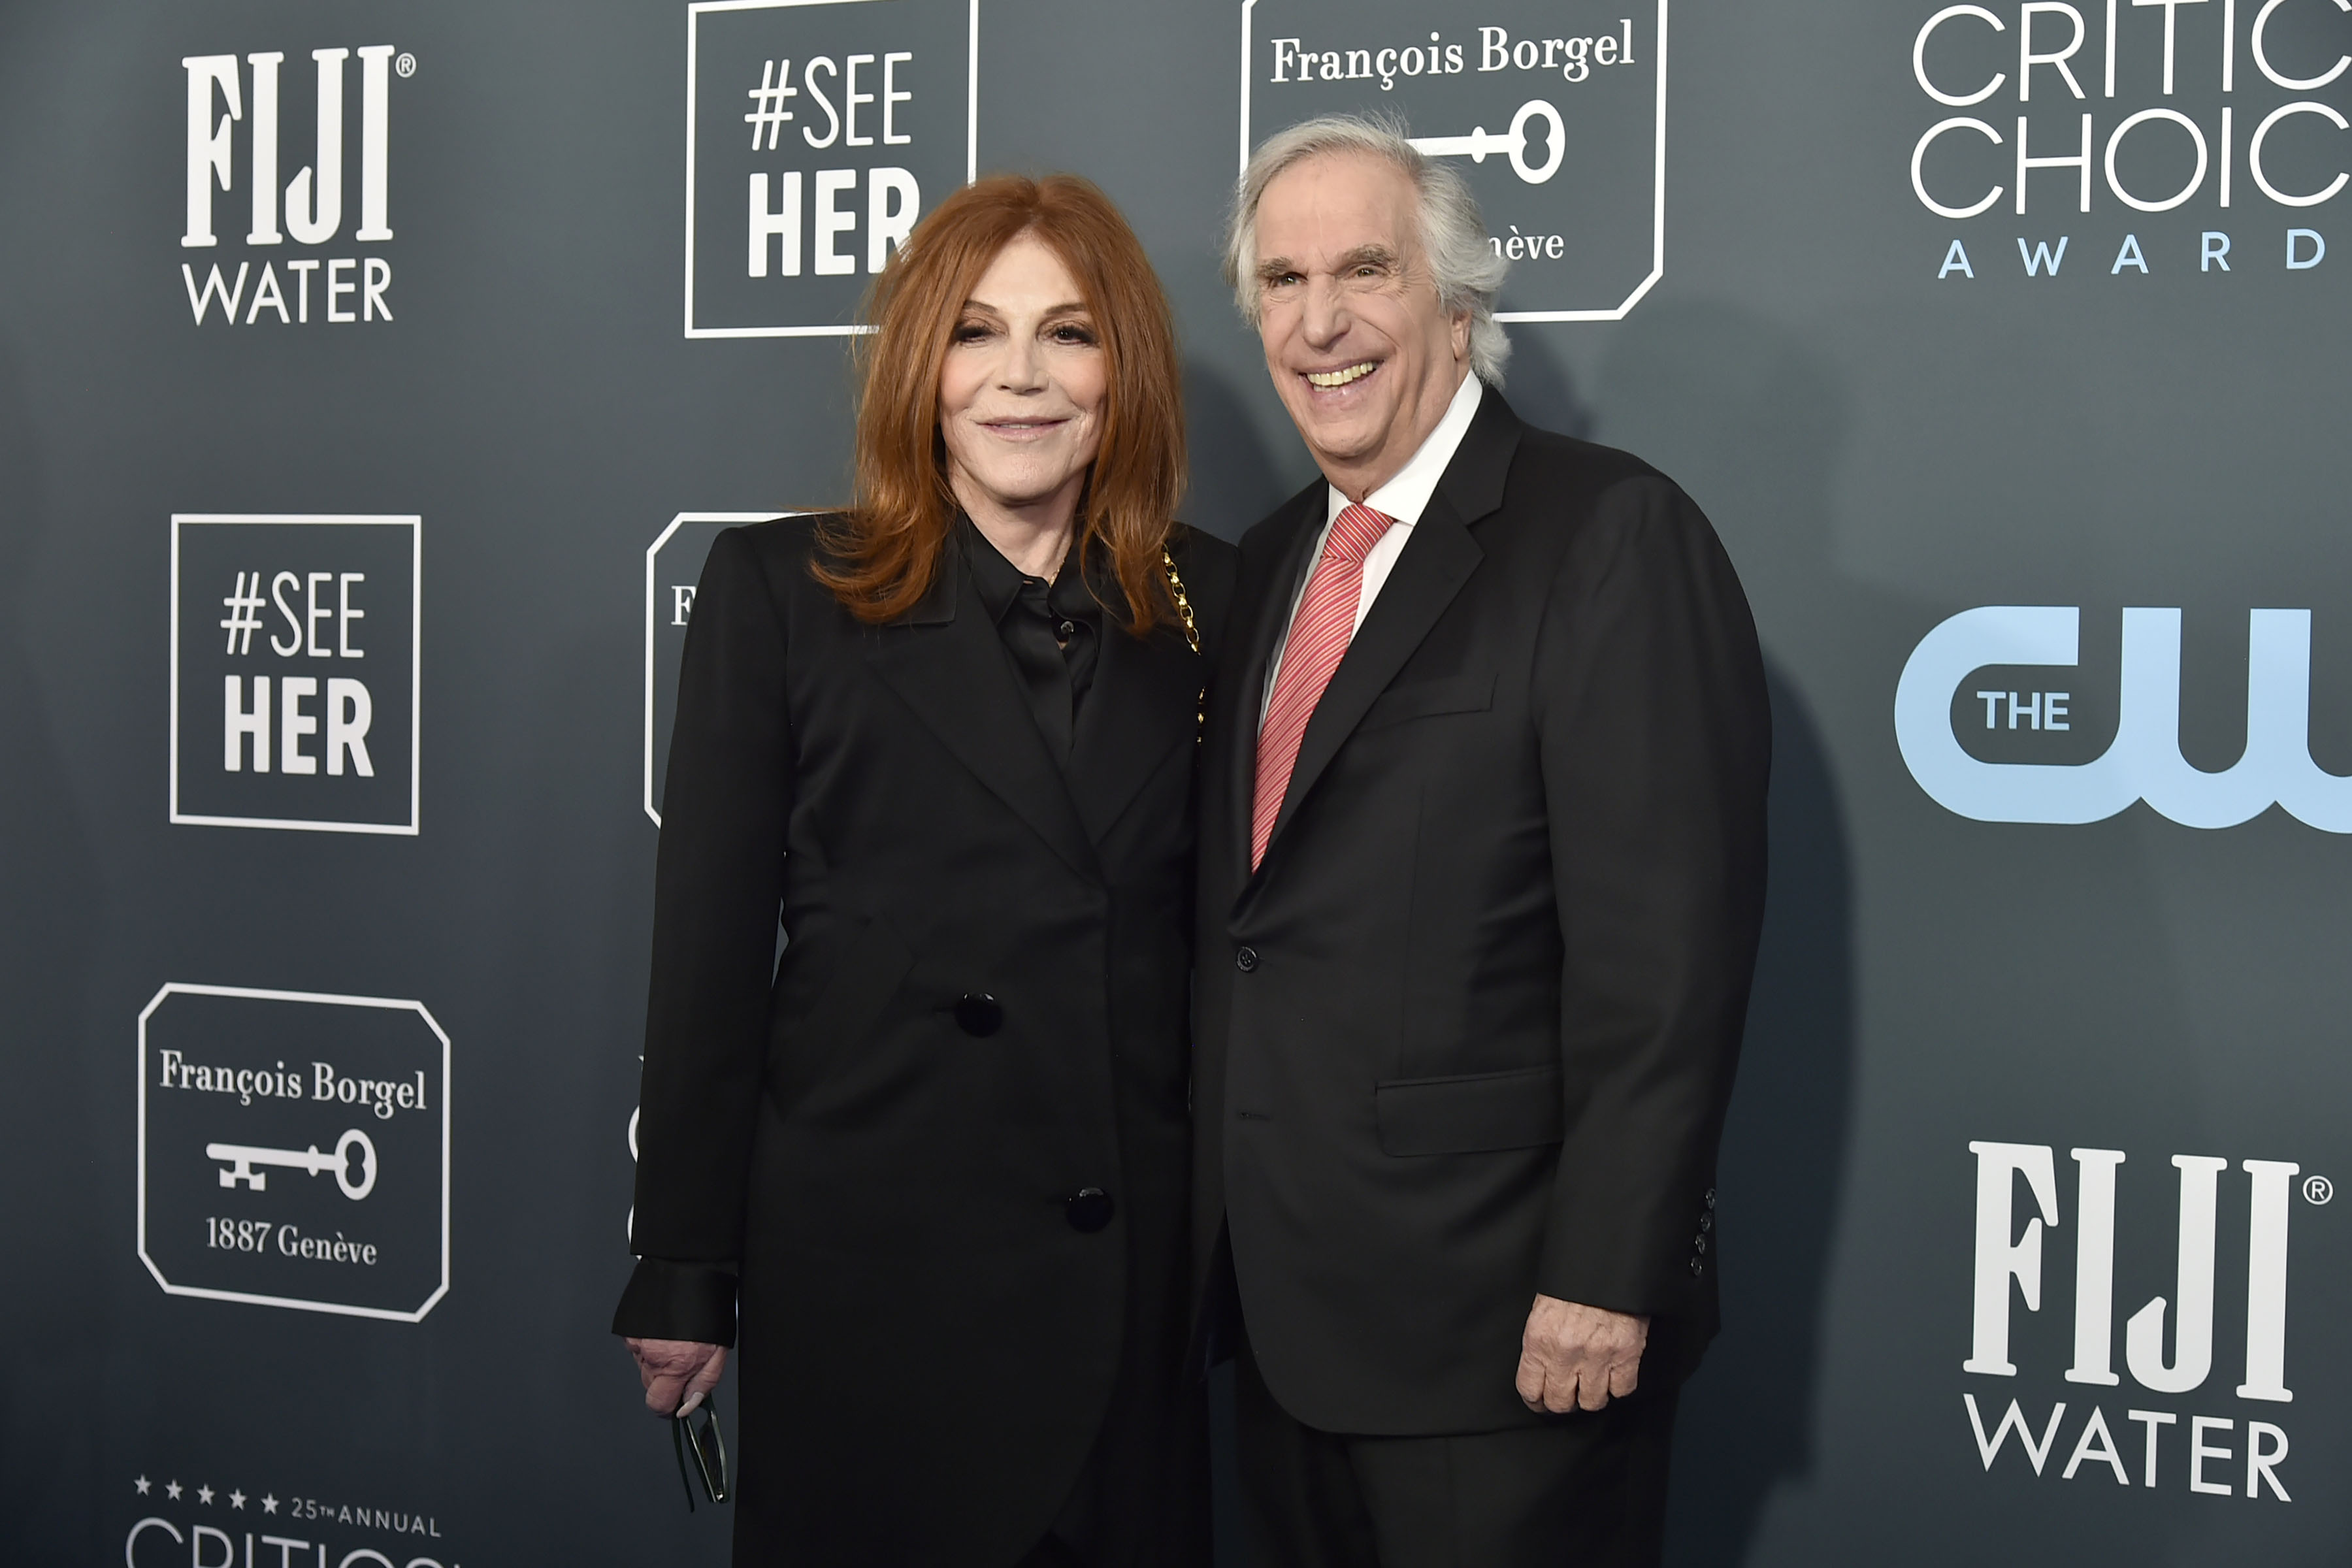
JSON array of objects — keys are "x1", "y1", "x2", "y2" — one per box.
[{"x1": 614, "y1": 517, "x2": 1237, "y2": 1565}]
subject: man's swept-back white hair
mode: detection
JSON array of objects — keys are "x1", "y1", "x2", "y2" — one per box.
[{"x1": 1226, "y1": 115, "x2": 1510, "y2": 385}]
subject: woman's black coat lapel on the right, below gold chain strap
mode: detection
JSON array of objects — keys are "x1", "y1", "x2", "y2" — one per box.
[{"x1": 1070, "y1": 609, "x2": 1202, "y2": 844}]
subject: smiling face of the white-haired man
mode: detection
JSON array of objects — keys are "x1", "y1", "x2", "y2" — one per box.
[{"x1": 1256, "y1": 153, "x2": 1470, "y2": 500}]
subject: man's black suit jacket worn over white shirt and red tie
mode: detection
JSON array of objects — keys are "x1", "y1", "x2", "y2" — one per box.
[{"x1": 1192, "y1": 388, "x2": 1771, "y2": 1434}]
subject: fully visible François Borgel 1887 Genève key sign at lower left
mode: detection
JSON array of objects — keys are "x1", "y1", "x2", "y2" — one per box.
[{"x1": 139, "y1": 983, "x2": 449, "y2": 1324}]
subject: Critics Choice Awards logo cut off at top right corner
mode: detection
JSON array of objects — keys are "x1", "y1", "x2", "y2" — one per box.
[{"x1": 1896, "y1": 0, "x2": 2352, "y2": 282}]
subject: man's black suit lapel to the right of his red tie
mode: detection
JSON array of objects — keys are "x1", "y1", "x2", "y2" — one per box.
[{"x1": 1261, "y1": 388, "x2": 1520, "y2": 870}]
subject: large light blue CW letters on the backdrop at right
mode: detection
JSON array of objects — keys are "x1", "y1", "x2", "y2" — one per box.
[{"x1": 1896, "y1": 604, "x2": 2352, "y2": 832}]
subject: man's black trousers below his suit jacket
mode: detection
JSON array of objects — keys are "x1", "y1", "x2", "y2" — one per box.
[{"x1": 1235, "y1": 1333, "x2": 1677, "y2": 1568}]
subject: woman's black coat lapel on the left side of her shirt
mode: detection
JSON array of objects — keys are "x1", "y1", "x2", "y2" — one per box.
[{"x1": 866, "y1": 546, "x2": 1101, "y2": 877}]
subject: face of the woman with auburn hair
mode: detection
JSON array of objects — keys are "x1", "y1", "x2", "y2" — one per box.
[{"x1": 938, "y1": 233, "x2": 1110, "y2": 522}]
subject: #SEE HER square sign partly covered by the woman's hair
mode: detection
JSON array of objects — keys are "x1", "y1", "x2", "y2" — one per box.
[{"x1": 687, "y1": 0, "x2": 981, "y2": 338}]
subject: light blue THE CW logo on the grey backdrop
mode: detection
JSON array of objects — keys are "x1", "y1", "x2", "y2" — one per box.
[{"x1": 1896, "y1": 604, "x2": 2352, "y2": 832}]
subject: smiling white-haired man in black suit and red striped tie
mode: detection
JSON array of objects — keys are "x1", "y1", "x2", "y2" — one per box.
[{"x1": 1195, "y1": 118, "x2": 1771, "y2": 1568}]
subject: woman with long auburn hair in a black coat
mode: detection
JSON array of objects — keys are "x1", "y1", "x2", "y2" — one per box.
[{"x1": 614, "y1": 176, "x2": 1235, "y2": 1568}]
